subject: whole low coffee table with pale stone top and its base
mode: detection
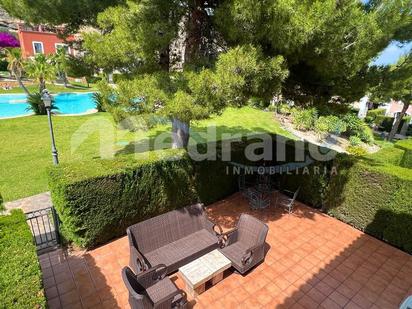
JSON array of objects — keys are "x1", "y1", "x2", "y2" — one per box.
[{"x1": 179, "y1": 249, "x2": 232, "y2": 297}]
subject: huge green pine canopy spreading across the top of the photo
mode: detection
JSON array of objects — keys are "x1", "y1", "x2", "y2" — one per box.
[{"x1": 4, "y1": 0, "x2": 412, "y2": 144}]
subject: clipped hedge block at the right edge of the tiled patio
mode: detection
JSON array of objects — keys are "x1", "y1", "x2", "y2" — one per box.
[{"x1": 327, "y1": 157, "x2": 412, "y2": 253}]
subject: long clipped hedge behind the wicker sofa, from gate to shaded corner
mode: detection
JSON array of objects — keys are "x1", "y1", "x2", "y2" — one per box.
[{"x1": 49, "y1": 150, "x2": 233, "y2": 247}]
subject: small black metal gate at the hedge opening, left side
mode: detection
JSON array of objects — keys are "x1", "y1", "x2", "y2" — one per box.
[{"x1": 26, "y1": 207, "x2": 60, "y2": 250}]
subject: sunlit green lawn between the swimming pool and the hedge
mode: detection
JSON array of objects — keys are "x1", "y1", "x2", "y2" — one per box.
[{"x1": 0, "y1": 107, "x2": 292, "y2": 201}]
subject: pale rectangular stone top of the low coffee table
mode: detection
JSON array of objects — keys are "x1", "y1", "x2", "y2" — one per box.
[{"x1": 179, "y1": 249, "x2": 232, "y2": 288}]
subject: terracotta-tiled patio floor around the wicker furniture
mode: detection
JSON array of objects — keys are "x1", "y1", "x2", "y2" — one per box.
[{"x1": 40, "y1": 194, "x2": 412, "y2": 309}]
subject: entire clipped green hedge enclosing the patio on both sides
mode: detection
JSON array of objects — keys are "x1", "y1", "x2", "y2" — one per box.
[{"x1": 50, "y1": 134, "x2": 412, "y2": 252}]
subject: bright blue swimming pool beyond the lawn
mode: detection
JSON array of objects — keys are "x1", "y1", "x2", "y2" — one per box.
[{"x1": 0, "y1": 92, "x2": 96, "y2": 118}]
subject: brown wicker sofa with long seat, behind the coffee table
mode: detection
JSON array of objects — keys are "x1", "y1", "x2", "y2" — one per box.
[{"x1": 127, "y1": 204, "x2": 222, "y2": 274}]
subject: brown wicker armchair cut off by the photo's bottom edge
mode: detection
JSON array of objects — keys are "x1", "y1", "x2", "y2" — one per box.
[{"x1": 122, "y1": 265, "x2": 187, "y2": 309}]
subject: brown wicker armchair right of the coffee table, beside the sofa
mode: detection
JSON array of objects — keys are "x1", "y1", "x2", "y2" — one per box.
[{"x1": 220, "y1": 214, "x2": 269, "y2": 274}]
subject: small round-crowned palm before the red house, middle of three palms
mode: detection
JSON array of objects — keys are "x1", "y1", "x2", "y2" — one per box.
[{"x1": 24, "y1": 54, "x2": 56, "y2": 93}]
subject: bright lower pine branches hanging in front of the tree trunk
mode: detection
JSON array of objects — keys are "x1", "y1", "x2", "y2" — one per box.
[{"x1": 107, "y1": 46, "x2": 287, "y2": 129}]
